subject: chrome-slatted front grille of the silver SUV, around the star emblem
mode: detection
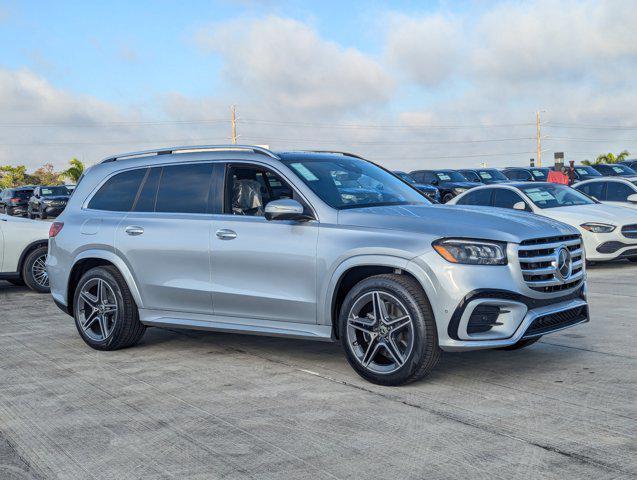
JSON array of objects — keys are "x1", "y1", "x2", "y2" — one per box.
[{"x1": 518, "y1": 235, "x2": 585, "y2": 293}]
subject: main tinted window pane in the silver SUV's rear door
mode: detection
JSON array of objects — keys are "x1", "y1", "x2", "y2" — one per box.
[{"x1": 155, "y1": 163, "x2": 213, "y2": 213}]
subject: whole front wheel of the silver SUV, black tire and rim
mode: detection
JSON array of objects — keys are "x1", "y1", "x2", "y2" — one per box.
[{"x1": 338, "y1": 274, "x2": 440, "y2": 386}]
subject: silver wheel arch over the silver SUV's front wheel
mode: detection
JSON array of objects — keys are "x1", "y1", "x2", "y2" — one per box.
[{"x1": 319, "y1": 255, "x2": 435, "y2": 338}]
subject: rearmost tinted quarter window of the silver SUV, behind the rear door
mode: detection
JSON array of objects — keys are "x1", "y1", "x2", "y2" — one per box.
[{"x1": 88, "y1": 168, "x2": 147, "y2": 212}]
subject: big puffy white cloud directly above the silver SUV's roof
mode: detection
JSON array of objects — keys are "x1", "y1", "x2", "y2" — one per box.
[{"x1": 197, "y1": 16, "x2": 393, "y2": 112}]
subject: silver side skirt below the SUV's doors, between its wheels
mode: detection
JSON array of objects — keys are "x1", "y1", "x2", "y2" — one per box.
[{"x1": 139, "y1": 308, "x2": 333, "y2": 342}]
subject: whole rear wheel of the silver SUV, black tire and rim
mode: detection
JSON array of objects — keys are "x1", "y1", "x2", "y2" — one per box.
[{"x1": 73, "y1": 266, "x2": 146, "y2": 350}]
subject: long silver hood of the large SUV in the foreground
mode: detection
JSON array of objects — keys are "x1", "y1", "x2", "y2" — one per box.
[{"x1": 338, "y1": 205, "x2": 578, "y2": 243}]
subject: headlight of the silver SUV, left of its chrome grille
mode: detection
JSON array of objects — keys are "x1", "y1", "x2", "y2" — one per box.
[{"x1": 432, "y1": 239, "x2": 507, "y2": 265}]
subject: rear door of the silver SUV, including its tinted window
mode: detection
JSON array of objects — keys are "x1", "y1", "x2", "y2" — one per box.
[{"x1": 115, "y1": 162, "x2": 214, "y2": 314}]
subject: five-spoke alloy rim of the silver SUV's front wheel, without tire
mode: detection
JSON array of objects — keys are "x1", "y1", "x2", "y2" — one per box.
[{"x1": 347, "y1": 291, "x2": 414, "y2": 374}]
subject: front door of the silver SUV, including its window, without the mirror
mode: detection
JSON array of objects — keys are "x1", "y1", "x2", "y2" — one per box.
[{"x1": 212, "y1": 164, "x2": 319, "y2": 323}]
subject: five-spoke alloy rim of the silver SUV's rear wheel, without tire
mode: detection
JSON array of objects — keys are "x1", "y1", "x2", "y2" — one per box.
[{"x1": 77, "y1": 278, "x2": 118, "y2": 342}]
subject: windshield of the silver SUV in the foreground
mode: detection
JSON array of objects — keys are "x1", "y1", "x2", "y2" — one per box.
[{"x1": 284, "y1": 157, "x2": 430, "y2": 209}]
